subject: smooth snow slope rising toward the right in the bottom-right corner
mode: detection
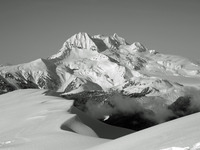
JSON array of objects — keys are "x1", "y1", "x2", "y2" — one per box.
[{"x1": 88, "y1": 113, "x2": 200, "y2": 150}]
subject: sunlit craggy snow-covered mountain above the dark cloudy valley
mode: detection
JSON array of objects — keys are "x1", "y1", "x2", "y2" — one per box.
[{"x1": 0, "y1": 32, "x2": 200, "y2": 94}]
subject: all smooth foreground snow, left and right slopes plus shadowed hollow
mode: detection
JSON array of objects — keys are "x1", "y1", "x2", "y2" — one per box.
[{"x1": 0, "y1": 89, "x2": 200, "y2": 150}]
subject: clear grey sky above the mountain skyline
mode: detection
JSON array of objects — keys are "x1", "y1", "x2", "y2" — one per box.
[{"x1": 0, "y1": 0, "x2": 200, "y2": 64}]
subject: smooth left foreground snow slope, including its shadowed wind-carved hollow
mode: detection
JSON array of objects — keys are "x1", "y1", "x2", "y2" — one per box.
[{"x1": 0, "y1": 89, "x2": 134, "y2": 150}]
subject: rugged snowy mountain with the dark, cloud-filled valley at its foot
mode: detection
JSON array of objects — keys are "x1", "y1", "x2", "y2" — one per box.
[{"x1": 0, "y1": 32, "x2": 200, "y2": 130}]
